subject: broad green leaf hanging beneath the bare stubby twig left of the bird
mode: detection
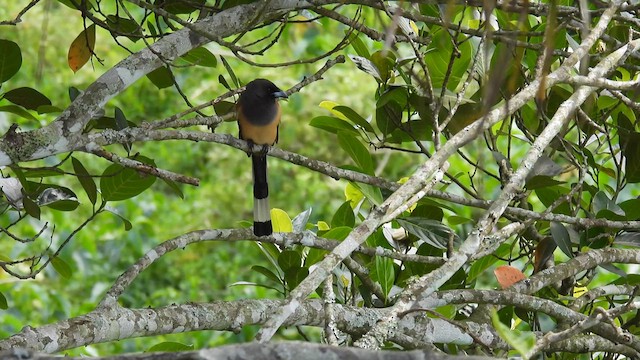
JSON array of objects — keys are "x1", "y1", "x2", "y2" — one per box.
[{"x1": 100, "y1": 156, "x2": 156, "y2": 201}]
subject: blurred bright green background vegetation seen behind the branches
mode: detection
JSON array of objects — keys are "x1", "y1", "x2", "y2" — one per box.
[{"x1": 0, "y1": 0, "x2": 412, "y2": 355}]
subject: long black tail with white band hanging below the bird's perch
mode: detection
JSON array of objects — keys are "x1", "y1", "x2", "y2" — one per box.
[{"x1": 251, "y1": 153, "x2": 273, "y2": 236}]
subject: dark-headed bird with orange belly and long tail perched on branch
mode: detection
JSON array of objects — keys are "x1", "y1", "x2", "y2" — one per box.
[{"x1": 236, "y1": 79, "x2": 288, "y2": 236}]
